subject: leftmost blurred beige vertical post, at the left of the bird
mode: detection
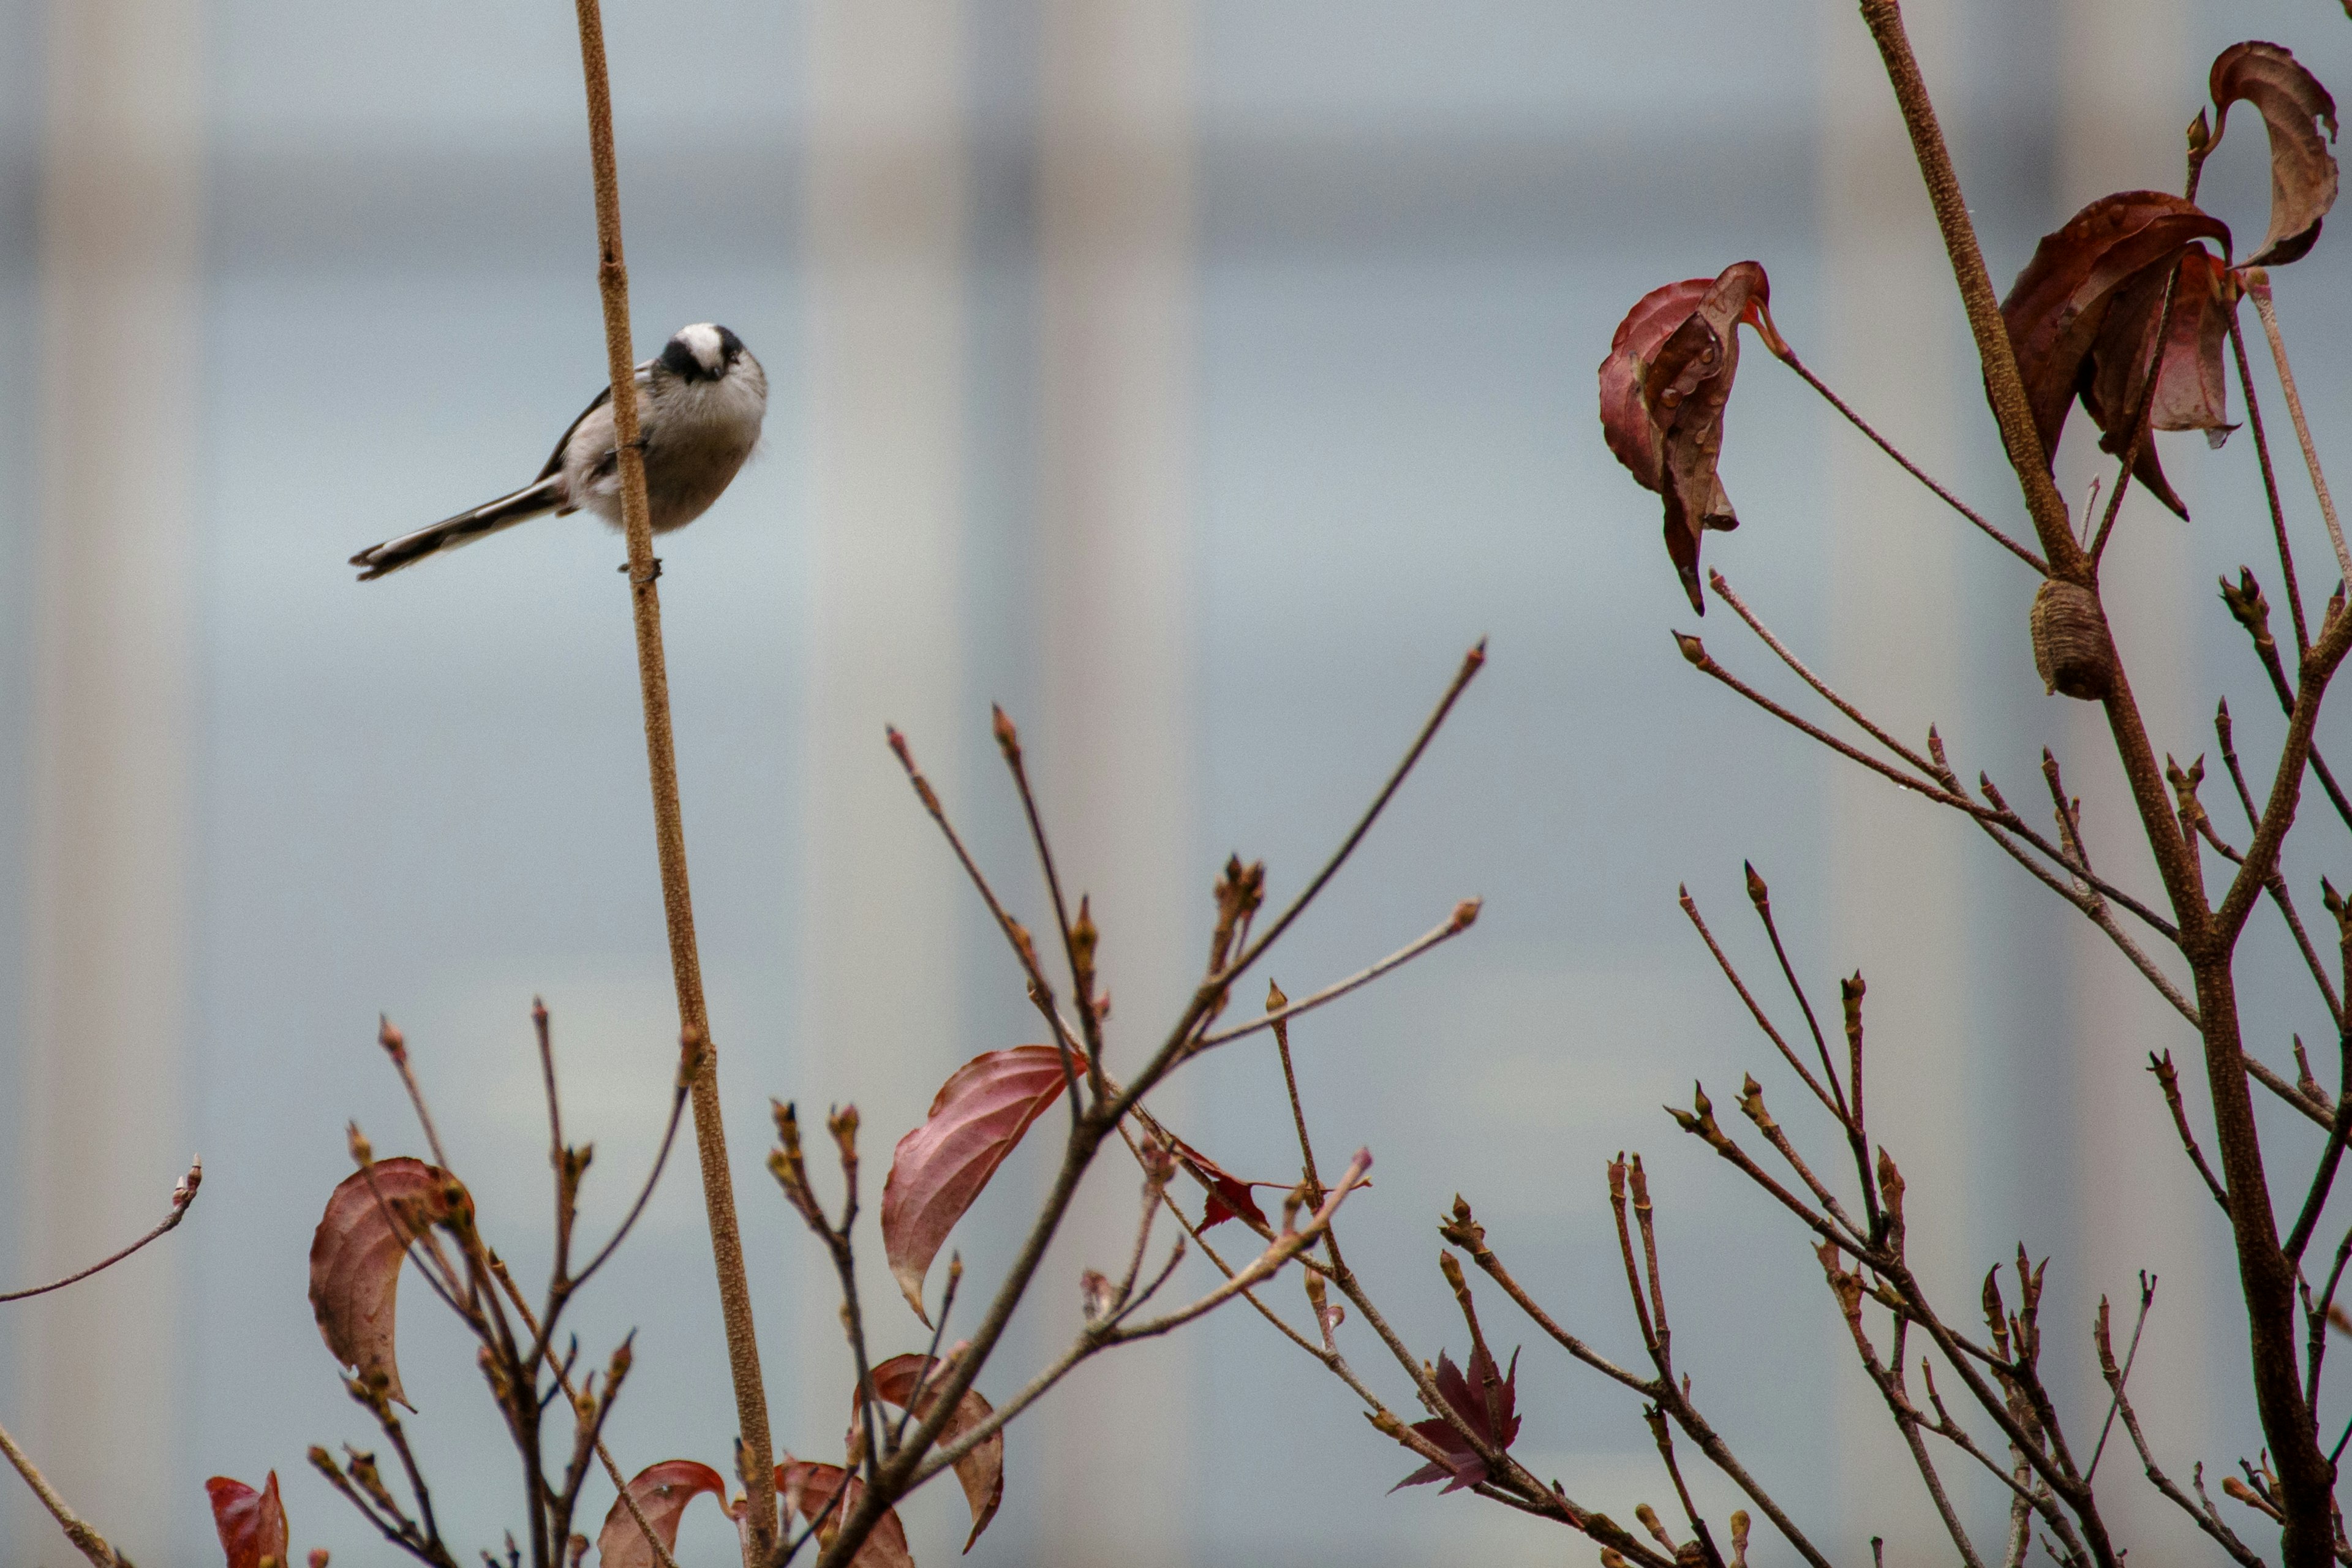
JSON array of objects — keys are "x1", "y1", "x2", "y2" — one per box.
[{"x1": 7, "y1": 0, "x2": 205, "y2": 1563}]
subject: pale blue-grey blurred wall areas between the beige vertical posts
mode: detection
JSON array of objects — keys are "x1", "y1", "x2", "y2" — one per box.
[{"x1": 0, "y1": 0, "x2": 2352, "y2": 1566}]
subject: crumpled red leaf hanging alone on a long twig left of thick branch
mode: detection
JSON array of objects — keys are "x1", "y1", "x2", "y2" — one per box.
[{"x1": 1602, "y1": 261, "x2": 1781, "y2": 614}]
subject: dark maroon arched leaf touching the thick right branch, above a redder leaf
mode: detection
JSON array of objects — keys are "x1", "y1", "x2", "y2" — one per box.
[{"x1": 2002, "y1": 190, "x2": 2230, "y2": 510}]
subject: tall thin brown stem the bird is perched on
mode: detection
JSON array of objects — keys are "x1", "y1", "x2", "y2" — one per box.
[{"x1": 574, "y1": 0, "x2": 776, "y2": 1563}]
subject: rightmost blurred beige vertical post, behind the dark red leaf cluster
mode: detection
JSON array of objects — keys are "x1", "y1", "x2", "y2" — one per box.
[{"x1": 2044, "y1": 0, "x2": 2201, "y2": 1559}]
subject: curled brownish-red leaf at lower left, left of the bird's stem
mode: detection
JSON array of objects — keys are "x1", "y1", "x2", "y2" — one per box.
[{"x1": 311, "y1": 1156, "x2": 473, "y2": 1408}]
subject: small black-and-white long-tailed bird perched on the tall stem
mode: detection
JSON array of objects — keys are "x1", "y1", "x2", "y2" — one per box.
[{"x1": 350, "y1": 322, "x2": 767, "y2": 583}]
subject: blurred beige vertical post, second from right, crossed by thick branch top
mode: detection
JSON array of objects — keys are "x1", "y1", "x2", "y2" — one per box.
[{"x1": 1804, "y1": 0, "x2": 1980, "y2": 1561}]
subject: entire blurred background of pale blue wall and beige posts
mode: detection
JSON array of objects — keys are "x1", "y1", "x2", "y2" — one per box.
[{"x1": 0, "y1": 0, "x2": 2352, "y2": 1568}]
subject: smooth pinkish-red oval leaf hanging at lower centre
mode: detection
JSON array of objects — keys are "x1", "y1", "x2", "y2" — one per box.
[{"x1": 882, "y1": 1046, "x2": 1063, "y2": 1324}]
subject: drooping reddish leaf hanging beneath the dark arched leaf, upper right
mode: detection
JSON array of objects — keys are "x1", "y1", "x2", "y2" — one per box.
[{"x1": 2081, "y1": 244, "x2": 2239, "y2": 517}]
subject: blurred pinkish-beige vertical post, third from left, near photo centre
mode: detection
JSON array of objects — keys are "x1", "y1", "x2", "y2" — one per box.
[{"x1": 1037, "y1": 0, "x2": 1212, "y2": 1568}]
